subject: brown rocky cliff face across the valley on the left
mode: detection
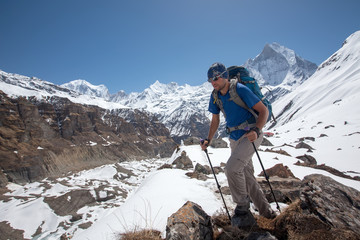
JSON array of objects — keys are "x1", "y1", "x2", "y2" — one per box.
[{"x1": 0, "y1": 91, "x2": 175, "y2": 187}]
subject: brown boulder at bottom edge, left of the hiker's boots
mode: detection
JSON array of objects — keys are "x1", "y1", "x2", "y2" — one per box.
[{"x1": 166, "y1": 201, "x2": 213, "y2": 240}]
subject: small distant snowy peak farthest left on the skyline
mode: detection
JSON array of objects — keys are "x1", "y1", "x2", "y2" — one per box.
[{"x1": 61, "y1": 79, "x2": 110, "y2": 99}]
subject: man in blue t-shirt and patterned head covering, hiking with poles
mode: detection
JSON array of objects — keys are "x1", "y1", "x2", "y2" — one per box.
[{"x1": 200, "y1": 63, "x2": 276, "y2": 227}]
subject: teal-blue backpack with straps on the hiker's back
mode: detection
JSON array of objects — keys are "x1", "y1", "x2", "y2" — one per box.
[{"x1": 212, "y1": 66, "x2": 276, "y2": 132}]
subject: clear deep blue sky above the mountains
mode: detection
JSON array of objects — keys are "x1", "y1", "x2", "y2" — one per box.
[{"x1": 0, "y1": 0, "x2": 360, "y2": 93}]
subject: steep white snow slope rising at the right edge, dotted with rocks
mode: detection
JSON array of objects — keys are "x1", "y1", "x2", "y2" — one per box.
[{"x1": 273, "y1": 31, "x2": 360, "y2": 172}]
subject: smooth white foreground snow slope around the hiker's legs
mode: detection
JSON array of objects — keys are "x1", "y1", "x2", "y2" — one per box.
[{"x1": 74, "y1": 142, "x2": 360, "y2": 239}]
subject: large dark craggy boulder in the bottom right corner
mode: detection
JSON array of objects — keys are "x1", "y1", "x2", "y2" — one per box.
[{"x1": 270, "y1": 174, "x2": 360, "y2": 240}]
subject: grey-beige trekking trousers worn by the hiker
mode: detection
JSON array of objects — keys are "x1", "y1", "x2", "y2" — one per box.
[{"x1": 225, "y1": 133, "x2": 271, "y2": 217}]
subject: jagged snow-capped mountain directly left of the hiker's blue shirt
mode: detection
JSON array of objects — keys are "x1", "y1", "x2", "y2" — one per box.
[{"x1": 116, "y1": 81, "x2": 212, "y2": 141}]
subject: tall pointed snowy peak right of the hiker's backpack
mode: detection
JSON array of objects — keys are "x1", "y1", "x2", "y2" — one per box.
[{"x1": 245, "y1": 43, "x2": 317, "y2": 86}]
